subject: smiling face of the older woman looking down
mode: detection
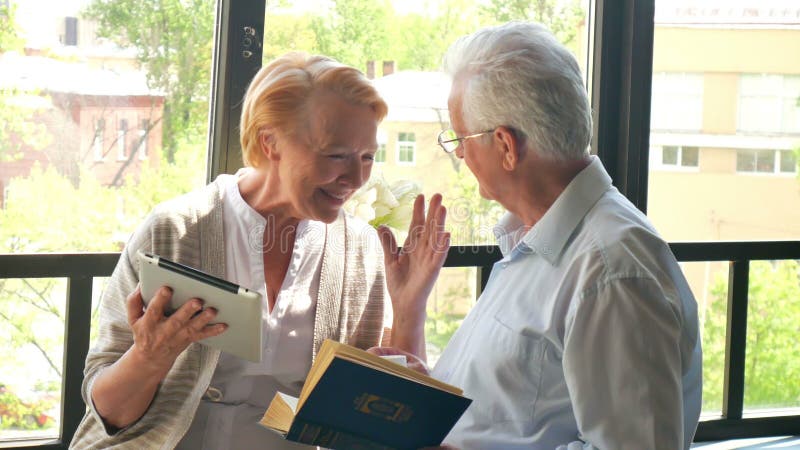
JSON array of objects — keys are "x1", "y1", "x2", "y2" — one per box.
[{"x1": 275, "y1": 91, "x2": 378, "y2": 223}]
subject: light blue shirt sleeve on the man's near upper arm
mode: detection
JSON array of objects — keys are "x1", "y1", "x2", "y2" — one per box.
[{"x1": 563, "y1": 278, "x2": 683, "y2": 449}]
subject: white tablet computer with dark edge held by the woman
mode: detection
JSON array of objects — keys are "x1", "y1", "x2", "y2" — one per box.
[{"x1": 138, "y1": 251, "x2": 262, "y2": 362}]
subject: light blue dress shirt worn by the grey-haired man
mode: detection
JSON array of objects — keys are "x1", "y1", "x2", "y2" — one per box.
[{"x1": 432, "y1": 157, "x2": 702, "y2": 450}]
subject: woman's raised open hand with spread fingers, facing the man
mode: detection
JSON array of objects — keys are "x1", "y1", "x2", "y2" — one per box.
[{"x1": 378, "y1": 194, "x2": 450, "y2": 320}]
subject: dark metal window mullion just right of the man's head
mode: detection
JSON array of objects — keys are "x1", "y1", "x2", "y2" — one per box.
[{"x1": 591, "y1": 0, "x2": 655, "y2": 212}]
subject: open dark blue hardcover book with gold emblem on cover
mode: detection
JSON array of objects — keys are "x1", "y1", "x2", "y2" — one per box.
[{"x1": 260, "y1": 340, "x2": 472, "y2": 450}]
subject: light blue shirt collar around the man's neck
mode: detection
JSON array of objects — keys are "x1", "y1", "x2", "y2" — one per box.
[{"x1": 494, "y1": 155, "x2": 611, "y2": 264}]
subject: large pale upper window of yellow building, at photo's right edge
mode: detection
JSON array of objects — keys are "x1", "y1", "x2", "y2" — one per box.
[{"x1": 738, "y1": 74, "x2": 800, "y2": 133}]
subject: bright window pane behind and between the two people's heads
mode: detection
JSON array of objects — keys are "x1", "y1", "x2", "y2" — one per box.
[{"x1": 264, "y1": 0, "x2": 588, "y2": 245}]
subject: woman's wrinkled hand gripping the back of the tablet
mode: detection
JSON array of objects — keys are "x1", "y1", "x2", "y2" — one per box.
[{"x1": 126, "y1": 286, "x2": 228, "y2": 374}]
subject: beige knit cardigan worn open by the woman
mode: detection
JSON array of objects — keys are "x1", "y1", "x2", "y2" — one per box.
[{"x1": 70, "y1": 179, "x2": 391, "y2": 450}]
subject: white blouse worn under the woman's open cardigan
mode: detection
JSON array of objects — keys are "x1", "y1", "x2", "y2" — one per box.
[{"x1": 177, "y1": 169, "x2": 325, "y2": 450}]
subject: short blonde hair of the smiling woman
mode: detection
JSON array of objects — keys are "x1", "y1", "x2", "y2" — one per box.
[{"x1": 239, "y1": 52, "x2": 388, "y2": 167}]
